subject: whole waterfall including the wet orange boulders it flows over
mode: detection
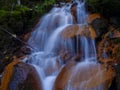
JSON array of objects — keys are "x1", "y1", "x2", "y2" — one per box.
[{"x1": 28, "y1": 0, "x2": 114, "y2": 90}]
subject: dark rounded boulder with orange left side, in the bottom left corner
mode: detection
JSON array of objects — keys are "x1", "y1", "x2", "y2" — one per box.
[{"x1": 1, "y1": 61, "x2": 42, "y2": 90}]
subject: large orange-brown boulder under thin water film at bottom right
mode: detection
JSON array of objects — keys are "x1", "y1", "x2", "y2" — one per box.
[{"x1": 54, "y1": 62, "x2": 114, "y2": 90}]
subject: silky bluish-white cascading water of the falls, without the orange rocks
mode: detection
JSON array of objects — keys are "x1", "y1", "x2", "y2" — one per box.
[{"x1": 28, "y1": 0, "x2": 102, "y2": 90}]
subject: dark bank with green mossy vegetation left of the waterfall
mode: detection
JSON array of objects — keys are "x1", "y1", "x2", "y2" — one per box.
[{"x1": 0, "y1": 0, "x2": 55, "y2": 61}]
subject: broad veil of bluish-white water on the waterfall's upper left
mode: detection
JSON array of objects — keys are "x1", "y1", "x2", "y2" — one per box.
[{"x1": 28, "y1": 7, "x2": 73, "y2": 51}]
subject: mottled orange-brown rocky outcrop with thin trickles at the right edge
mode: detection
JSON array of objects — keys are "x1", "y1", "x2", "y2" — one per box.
[{"x1": 97, "y1": 26, "x2": 120, "y2": 65}]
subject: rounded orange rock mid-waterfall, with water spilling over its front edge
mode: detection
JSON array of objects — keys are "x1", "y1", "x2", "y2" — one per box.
[{"x1": 61, "y1": 24, "x2": 96, "y2": 39}]
